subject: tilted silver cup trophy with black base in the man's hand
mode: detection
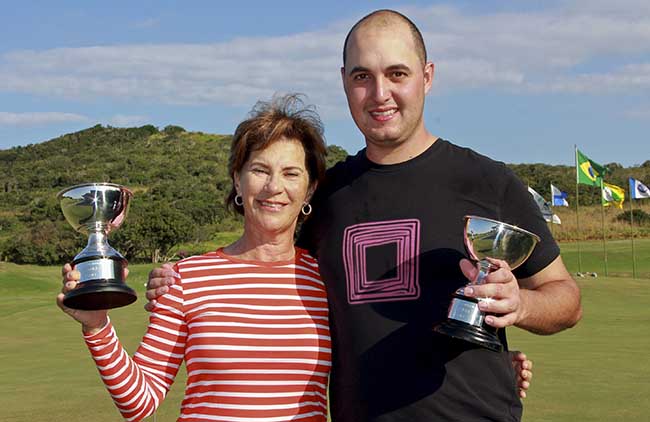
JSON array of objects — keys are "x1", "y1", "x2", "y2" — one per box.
[{"x1": 434, "y1": 215, "x2": 540, "y2": 352}]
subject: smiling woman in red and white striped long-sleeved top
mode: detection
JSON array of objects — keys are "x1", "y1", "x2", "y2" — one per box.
[{"x1": 57, "y1": 96, "x2": 331, "y2": 421}]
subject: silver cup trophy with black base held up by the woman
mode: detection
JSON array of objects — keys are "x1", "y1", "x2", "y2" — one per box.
[{"x1": 57, "y1": 183, "x2": 137, "y2": 310}]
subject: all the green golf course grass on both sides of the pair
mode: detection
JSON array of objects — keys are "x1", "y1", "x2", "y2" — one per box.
[{"x1": 0, "y1": 239, "x2": 650, "y2": 422}]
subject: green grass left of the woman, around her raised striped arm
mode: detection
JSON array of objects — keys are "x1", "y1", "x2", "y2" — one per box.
[{"x1": 0, "y1": 263, "x2": 185, "y2": 422}]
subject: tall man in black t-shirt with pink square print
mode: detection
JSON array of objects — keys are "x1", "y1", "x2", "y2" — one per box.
[{"x1": 148, "y1": 10, "x2": 581, "y2": 422}]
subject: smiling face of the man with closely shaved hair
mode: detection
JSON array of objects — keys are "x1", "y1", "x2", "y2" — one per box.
[{"x1": 341, "y1": 23, "x2": 433, "y2": 149}]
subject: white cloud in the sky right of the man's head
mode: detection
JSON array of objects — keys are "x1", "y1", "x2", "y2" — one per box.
[{"x1": 416, "y1": 2, "x2": 650, "y2": 94}]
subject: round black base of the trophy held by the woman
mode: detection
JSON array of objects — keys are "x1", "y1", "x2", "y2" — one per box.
[{"x1": 63, "y1": 280, "x2": 138, "y2": 311}]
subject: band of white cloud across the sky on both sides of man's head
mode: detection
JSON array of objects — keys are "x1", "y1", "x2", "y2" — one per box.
[{"x1": 0, "y1": 0, "x2": 650, "y2": 115}]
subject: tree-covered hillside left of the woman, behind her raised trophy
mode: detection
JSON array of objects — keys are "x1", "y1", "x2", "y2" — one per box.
[{"x1": 0, "y1": 125, "x2": 232, "y2": 265}]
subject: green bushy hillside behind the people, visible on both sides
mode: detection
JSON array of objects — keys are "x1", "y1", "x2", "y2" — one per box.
[{"x1": 0, "y1": 125, "x2": 650, "y2": 265}]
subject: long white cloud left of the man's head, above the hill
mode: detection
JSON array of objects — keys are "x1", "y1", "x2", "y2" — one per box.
[{"x1": 0, "y1": 34, "x2": 340, "y2": 109}]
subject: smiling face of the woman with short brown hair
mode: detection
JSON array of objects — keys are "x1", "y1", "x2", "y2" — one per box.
[{"x1": 235, "y1": 138, "x2": 313, "y2": 236}]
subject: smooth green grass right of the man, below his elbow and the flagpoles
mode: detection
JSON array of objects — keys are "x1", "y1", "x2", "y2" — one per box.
[{"x1": 509, "y1": 277, "x2": 650, "y2": 422}]
